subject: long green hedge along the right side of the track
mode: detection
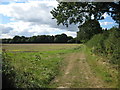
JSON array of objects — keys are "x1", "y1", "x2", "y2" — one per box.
[{"x1": 86, "y1": 27, "x2": 120, "y2": 64}]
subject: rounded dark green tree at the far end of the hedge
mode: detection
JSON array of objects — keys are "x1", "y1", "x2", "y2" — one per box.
[{"x1": 77, "y1": 20, "x2": 102, "y2": 43}]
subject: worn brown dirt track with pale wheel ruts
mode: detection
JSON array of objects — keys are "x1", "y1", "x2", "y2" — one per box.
[{"x1": 54, "y1": 52, "x2": 104, "y2": 88}]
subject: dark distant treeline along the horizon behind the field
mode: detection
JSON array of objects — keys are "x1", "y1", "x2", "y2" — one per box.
[{"x1": 2, "y1": 34, "x2": 76, "y2": 44}]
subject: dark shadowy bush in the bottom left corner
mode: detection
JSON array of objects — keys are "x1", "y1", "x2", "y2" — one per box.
[{"x1": 2, "y1": 52, "x2": 16, "y2": 89}]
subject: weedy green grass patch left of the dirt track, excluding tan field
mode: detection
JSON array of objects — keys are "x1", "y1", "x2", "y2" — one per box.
[{"x1": 8, "y1": 53, "x2": 62, "y2": 88}]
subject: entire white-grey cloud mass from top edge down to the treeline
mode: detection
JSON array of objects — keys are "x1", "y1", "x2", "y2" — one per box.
[{"x1": 0, "y1": 1, "x2": 78, "y2": 37}]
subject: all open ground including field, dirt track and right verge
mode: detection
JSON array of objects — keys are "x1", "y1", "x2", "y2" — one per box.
[{"x1": 2, "y1": 44, "x2": 118, "y2": 88}]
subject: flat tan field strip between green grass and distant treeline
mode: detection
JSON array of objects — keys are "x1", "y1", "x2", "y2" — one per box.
[{"x1": 2, "y1": 44, "x2": 78, "y2": 51}]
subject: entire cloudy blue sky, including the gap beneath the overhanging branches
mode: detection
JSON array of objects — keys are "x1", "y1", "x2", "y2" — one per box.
[{"x1": 0, "y1": 0, "x2": 117, "y2": 38}]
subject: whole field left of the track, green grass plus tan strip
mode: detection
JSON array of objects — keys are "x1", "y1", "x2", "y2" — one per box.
[{"x1": 3, "y1": 44, "x2": 79, "y2": 88}]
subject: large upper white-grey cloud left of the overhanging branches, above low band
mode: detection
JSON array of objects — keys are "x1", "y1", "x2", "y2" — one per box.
[{"x1": 0, "y1": 1, "x2": 76, "y2": 30}]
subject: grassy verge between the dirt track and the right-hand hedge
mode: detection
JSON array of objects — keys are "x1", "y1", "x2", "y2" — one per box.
[{"x1": 83, "y1": 45, "x2": 118, "y2": 88}]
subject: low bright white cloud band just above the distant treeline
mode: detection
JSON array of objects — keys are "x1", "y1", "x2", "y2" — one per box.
[{"x1": 0, "y1": 21, "x2": 76, "y2": 38}]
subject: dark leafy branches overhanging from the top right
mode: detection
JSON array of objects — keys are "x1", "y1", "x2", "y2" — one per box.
[{"x1": 51, "y1": 1, "x2": 120, "y2": 27}]
